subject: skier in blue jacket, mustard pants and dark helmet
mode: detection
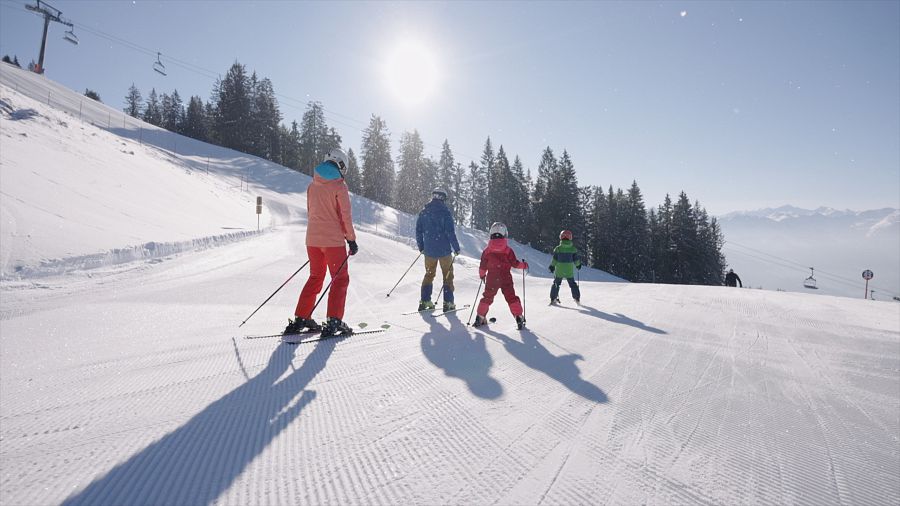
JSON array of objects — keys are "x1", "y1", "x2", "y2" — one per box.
[{"x1": 416, "y1": 188, "x2": 459, "y2": 311}]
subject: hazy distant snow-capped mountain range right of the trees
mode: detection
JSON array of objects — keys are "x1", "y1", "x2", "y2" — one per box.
[{"x1": 719, "y1": 205, "x2": 900, "y2": 299}]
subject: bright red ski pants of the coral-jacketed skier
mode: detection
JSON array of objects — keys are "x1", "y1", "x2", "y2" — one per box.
[{"x1": 294, "y1": 246, "x2": 350, "y2": 320}]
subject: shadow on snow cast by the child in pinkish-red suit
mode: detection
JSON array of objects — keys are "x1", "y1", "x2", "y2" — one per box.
[{"x1": 478, "y1": 327, "x2": 609, "y2": 403}]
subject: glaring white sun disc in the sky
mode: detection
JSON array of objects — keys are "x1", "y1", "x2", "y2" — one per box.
[{"x1": 385, "y1": 41, "x2": 438, "y2": 105}]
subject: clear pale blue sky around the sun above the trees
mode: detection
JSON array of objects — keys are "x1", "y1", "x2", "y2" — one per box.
[{"x1": 0, "y1": 0, "x2": 900, "y2": 214}]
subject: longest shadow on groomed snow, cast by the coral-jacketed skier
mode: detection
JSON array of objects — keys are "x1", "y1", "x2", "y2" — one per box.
[{"x1": 63, "y1": 339, "x2": 337, "y2": 505}]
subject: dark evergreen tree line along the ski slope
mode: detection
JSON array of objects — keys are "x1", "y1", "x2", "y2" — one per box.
[{"x1": 125, "y1": 63, "x2": 725, "y2": 285}]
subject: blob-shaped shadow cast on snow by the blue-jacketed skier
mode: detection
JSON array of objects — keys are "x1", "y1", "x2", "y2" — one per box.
[{"x1": 422, "y1": 313, "x2": 503, "y2": 399}]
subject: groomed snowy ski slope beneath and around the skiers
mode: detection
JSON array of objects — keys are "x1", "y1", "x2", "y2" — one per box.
[{"x1": 0, "y1": 66, "x2": 900, "y2": 505}]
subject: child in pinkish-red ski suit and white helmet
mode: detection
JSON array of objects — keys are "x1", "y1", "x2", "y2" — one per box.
[{"x1": 475, "y1": 222, "x2": 528, "y2": 328}]
